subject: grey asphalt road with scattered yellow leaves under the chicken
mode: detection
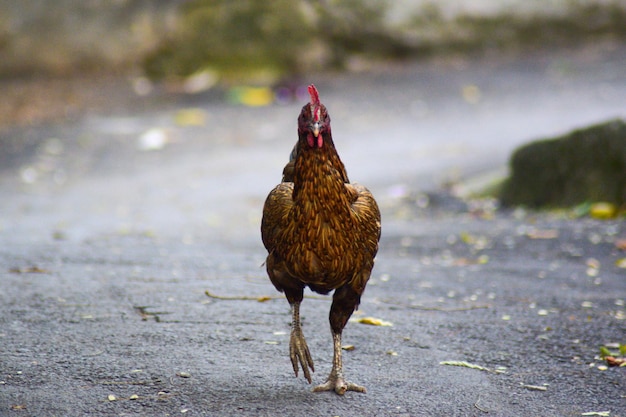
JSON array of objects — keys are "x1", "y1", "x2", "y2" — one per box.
[{"x1": 0, "y1": 45, "x2": 626, "y2": 417}]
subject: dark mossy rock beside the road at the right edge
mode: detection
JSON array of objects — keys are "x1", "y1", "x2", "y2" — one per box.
[{"x1": 500, "y1": 120, "x2": 626, "y2": 207}]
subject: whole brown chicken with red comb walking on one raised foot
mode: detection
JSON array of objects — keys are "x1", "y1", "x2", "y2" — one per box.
[{"x1": 261, "y1": 85, "x2": 380, "y2": 395}]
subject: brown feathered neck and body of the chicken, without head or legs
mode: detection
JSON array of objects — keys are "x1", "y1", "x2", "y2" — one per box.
[{"x1": 261, "y1": 99, "x2": 381, "y2": 295}]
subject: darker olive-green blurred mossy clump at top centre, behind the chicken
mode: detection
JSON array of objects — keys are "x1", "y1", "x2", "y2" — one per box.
[{"x1": 144, "y1": 0, "x2": 402, "y2": 82}]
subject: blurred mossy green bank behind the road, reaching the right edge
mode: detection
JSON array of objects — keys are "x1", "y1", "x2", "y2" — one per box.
[{"x1": 144, "y1": 0, "x2": 626, "y2": 84}]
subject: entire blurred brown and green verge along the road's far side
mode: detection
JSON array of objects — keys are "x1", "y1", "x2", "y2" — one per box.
[{"x1": 0, "y1": 0, "x2": 626, "y2": 124}]
